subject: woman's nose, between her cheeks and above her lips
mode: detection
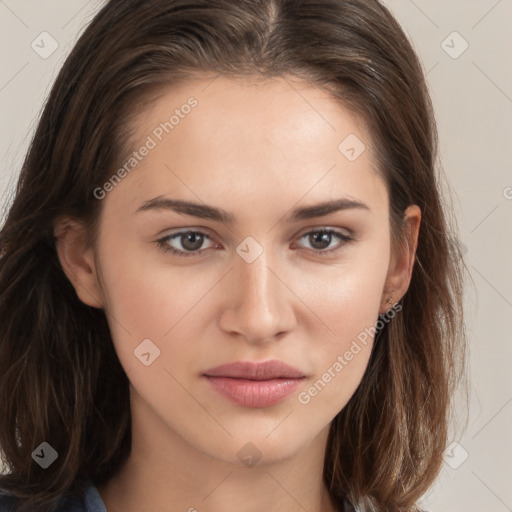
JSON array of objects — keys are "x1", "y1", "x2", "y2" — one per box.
[{"x1": 219, "y1": 247, "x2": 295, "y2": 344}]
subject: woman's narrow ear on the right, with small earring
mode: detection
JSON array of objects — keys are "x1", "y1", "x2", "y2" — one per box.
[{"x1": 379, "y1": 205, "x2": 421, "y2": 314}]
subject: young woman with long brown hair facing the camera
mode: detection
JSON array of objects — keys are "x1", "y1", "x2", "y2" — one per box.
[{"x1": 0, "y1": 0, "x2": 464, "y2": 512}]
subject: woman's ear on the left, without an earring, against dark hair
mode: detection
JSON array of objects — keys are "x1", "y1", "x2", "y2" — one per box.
[{"x1": 54, "y1": 217, "x2": 104, "y2": 308}]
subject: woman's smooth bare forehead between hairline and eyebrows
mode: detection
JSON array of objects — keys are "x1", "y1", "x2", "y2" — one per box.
[{"x1": 109, "y1": 76, "x2": 387, "y2": 218}]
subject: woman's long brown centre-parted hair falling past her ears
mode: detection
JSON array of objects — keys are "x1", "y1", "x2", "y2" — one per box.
[{"x1": 0, "y1": 0, "x2": 465, "y2": 512}]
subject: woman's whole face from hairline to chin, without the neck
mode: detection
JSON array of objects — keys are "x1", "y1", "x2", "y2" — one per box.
[{"x1": 59, "y1": 77, "x2": 416, "y2": 463}]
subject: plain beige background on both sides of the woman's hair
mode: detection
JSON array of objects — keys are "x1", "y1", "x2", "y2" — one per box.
[{"x1": 0, "y1": 0, "x2": 512, "y2": 512}]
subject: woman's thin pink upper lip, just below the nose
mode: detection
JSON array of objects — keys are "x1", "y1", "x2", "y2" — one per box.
[{"x1": 204, "y1": 360, "x2": 305, "y2": 380}]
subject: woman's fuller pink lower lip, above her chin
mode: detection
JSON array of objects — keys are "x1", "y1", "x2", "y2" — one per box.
[{"x1": 205, "y1": 375, "x2": 303, "y2": 407}]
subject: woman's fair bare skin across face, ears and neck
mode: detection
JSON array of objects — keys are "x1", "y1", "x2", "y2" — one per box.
[{"x1": 55, "y1": 77, "x2": 421, "y2": 512}]
